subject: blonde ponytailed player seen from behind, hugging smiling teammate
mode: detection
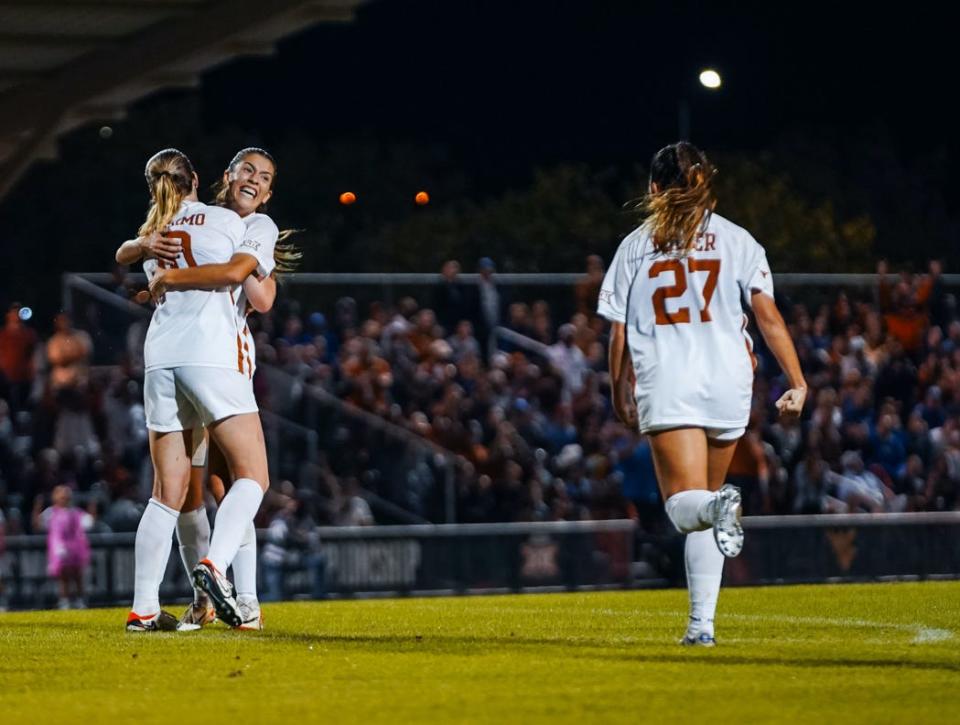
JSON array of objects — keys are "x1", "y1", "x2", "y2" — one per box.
[{"x1": 118, "y1": 149, "x2": 269, "y2": 631}]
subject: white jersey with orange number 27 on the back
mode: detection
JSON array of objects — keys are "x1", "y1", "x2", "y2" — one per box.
[{"x1": 597, "y1": 214, "x2": 773, "y2": 431}]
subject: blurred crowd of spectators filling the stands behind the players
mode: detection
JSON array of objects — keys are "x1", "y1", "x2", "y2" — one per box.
[{"x1": 0, "y1": 256, "x2": 960, "y2": 556}]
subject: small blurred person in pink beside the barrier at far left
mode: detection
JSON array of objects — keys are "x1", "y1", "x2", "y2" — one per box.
[{"x1": 34, "y1": 486, "x2": 92, "y2": 609}]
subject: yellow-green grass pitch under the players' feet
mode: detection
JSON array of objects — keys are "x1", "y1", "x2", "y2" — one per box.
[{"x1": 0, "y1": 582, "x2": 960, "y2": 725}]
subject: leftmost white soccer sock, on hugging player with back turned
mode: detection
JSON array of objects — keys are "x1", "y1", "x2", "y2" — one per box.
[{"x1": 133, "y1": 498, "x2": 179, "y2": 616}]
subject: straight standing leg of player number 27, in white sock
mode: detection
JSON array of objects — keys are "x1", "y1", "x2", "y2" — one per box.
[{"x1": 683, "y1": 437, "x2": 737, "y2": 646}]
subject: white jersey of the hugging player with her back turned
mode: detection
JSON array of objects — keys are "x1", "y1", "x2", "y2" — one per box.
[{"x1": 143, "y1": 201, "x2": 248, "y2": 370}]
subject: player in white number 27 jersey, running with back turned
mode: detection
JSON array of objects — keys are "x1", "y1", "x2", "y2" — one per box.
[{"x1": 597, "y1": 142, "x2": 807, "y2": 646}]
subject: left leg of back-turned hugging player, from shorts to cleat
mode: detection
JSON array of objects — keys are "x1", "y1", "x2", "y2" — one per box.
[{"x1": 127, "y1": 370, "x2": 192, "y2": 632}]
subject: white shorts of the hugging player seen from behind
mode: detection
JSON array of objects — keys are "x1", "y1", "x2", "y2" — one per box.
[{"x1": 143, "y1": 366, "x2": 258, "y2": 433}]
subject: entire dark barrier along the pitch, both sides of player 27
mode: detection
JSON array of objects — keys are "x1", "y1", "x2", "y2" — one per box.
[{"x1": 3, "y1": 512, "x2": 960, "y2": 608}]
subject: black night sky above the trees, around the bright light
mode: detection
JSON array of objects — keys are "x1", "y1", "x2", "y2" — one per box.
[{"x1": 200, "y1": 0, "x2": 954, "y2": 184}]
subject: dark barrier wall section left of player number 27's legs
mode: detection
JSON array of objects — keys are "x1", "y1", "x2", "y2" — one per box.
[{"x1": 4, "y1": 521, "x2": 635, "y2": 608}]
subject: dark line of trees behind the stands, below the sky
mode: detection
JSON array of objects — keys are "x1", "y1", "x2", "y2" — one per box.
[{"x1": 0, "y1": 95, "x2": 958, "y2": 324}]
